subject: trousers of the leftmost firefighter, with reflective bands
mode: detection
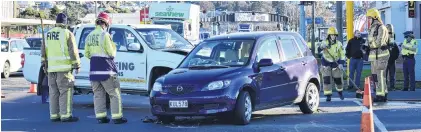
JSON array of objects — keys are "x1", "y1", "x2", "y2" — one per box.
[{"x1": 48, "y1": 71, "x2": 74, "y2": 119}]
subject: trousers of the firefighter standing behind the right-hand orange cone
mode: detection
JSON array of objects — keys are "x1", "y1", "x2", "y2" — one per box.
[{"x1": 371, "y1": 56, "x2": 389, "y2": 96}]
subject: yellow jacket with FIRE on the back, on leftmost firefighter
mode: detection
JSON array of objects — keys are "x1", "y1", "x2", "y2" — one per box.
[{"x1": 45, "y1": 27, "x2": 72, "y2": 72}]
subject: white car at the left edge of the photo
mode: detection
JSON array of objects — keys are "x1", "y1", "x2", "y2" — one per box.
[{"x1": 0, "y1": 38, "x2": 29, "y2": 78}]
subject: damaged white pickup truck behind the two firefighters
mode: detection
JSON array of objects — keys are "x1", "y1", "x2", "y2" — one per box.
[{"x1": 23, "y1": 24, "x2": 194, "y2": 94}]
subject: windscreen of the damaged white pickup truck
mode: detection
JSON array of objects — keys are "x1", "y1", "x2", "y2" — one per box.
[{"x1": 135, "y1": 28, "x2": 193, "y2": 49}]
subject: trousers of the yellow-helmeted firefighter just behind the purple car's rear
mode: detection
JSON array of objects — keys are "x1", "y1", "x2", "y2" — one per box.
[{"x1": 321, "y1": 66, "x2": 343, "y2": 96}]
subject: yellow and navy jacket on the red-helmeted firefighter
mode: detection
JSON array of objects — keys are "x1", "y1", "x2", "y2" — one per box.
[{"x1": 85, "y1": 26, "x2": 117, "y2": 81}]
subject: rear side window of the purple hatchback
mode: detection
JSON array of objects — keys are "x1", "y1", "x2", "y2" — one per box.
[{"x1": 280, "y1": 38, "x2": 302, "y2": 60}]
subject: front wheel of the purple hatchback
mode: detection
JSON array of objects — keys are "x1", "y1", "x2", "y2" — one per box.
[{"x1": 234, "y1": 91, "x2": 249, "y2": 125}]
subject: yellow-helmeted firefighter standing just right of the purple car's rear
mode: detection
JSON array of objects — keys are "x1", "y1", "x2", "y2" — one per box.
[{"x1": 319, "y1": 27, "x2": 345, "y2": 101}]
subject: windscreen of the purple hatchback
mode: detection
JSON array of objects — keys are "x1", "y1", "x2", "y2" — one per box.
[{"x1": 180, "y1": 40, "x2": 255, "y2": 68}]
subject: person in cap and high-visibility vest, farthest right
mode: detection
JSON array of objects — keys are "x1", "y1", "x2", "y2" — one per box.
[{"x1": 402, "y1": 31, "x2": 418, "y2": 91}]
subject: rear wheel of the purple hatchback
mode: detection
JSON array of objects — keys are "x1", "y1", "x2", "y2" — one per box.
[{"x1": 299, "y1": 82, "x2": 320, "y2": 114}]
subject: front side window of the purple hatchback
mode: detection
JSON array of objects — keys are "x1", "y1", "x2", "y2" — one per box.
[{"x1": 257, "y1": 38, "x2": 281, "y2": 63}]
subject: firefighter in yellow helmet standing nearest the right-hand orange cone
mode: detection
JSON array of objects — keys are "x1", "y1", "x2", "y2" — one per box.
[{"x1": 366, "y1": 8, "x2": 390, "y2": 102}]
